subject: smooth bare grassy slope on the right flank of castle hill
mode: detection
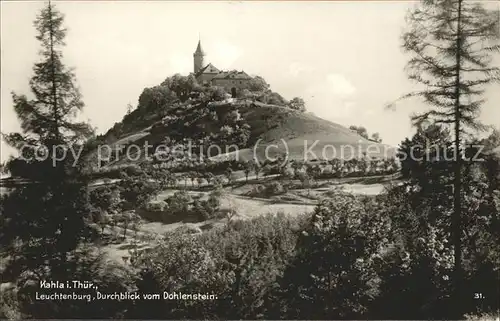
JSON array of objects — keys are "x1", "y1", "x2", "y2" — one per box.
[{"x1": 202, "y1": 104, "x2": 395, "y2": 161}]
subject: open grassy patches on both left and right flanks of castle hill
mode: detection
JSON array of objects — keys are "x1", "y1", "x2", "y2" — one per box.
[{"x1": 94, "y1": 101, "x2": 395, "y2": 166}]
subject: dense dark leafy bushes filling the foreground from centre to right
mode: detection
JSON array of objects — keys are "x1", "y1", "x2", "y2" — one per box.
[{"x1": 124, "y1": 170, "x2": 500, "y2": 319}]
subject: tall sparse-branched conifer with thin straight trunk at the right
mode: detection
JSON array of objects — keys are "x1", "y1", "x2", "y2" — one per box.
[{"x1": 396, "y1": 0, "x2": 500, "y2": 307}]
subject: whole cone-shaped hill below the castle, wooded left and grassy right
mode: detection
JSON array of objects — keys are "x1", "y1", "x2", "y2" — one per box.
[{"x1": 87, "y1": 75, "x2": 391, "y2": 169}]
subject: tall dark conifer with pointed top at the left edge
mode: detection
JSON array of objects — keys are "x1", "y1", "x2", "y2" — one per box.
[{"x1": 0, "y1": 2, "x2": 92, "y2": 287}]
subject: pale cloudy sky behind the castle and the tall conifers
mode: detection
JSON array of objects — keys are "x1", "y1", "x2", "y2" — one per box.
[{"x1": 0, "y1": 1, "x2": 500, "y2": 161}]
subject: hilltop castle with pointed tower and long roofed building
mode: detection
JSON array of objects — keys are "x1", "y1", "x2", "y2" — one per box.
[{"x1": 193, "y1": 40, "x2": 252, "y2": 96}]
